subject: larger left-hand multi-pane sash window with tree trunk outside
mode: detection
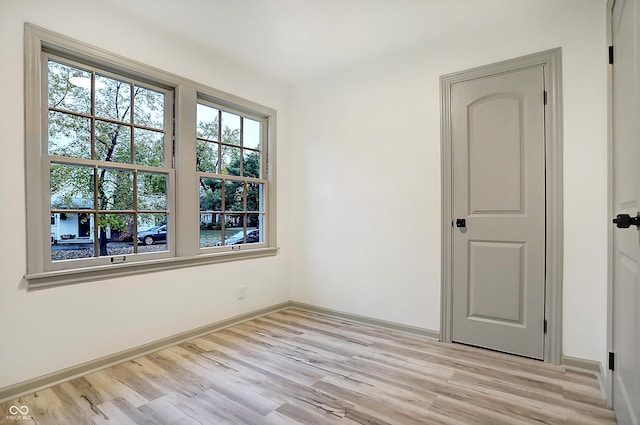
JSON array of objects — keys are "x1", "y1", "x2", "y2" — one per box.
[{"x1": 42, "y1": 52, "x2": 173, "y2": 269}]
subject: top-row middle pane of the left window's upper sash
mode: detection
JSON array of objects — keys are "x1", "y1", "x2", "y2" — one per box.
[{"x1": 96, "y1": 75, "x2": 131, "y2": 122}]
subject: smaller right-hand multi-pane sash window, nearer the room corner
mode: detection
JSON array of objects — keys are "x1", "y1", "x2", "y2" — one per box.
[{"x1": 196, "y1": 101, "x2": 268, "y2": 248}]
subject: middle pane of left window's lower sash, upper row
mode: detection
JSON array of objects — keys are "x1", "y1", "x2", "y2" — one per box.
[{"x1": 98, "y1": 168, "x2": 133, "y2": 210}]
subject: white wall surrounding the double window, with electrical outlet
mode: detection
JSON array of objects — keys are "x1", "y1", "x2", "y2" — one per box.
[{"x1": 0, "y1": 0, "x2": 290, "y2": 388}]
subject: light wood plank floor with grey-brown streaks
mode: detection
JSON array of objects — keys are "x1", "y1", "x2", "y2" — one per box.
[{"x1": 0, "y1": 309, "x2": 615, "y2": 425}]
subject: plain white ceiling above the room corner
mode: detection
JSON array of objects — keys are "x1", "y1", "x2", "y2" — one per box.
[{"x1": 113, "y1": 0, "x2": 552, "y2": 81}]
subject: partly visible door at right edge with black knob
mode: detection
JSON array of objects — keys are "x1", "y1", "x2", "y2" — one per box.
[{"x1": 612, "y1": 0, "x2": 640, "y2": 425}]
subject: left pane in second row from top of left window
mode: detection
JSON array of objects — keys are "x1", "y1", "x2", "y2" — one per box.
[{"x1": 49, "y1": 111, "x2": 91, "y2": 159}]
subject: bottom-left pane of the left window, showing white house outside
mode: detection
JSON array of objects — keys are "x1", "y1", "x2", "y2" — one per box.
[{"x1": 51, "y1": 212, "x2": 95, "y2": 261}]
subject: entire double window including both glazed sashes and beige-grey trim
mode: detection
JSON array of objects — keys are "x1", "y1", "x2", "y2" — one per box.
[{"x1": 25, "y1": 24, "x2": 277, "y2": 287}]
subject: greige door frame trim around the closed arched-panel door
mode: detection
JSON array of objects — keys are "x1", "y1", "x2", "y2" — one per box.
[{"x1": 440, "y1": 48, "x2": 562, "y2": 364}]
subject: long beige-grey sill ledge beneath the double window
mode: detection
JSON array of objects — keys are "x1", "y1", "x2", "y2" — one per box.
[{"x1": 24, "y1": 248, "x2": 279, "y2": 290}]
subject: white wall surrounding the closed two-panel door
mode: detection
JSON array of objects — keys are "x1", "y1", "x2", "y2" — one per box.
[{"x1": 291, "y1": 0, "x2": 608, "y2": 361}]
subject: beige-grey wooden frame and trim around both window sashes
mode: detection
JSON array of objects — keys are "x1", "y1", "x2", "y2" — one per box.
[{"x1": 24, "y1": 23, "x2": 278, "y2": 289}]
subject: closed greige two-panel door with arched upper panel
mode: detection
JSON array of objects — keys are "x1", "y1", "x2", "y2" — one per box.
[{"x1": 451, "y1": 65, "x2": 546, "y2": 359}]
